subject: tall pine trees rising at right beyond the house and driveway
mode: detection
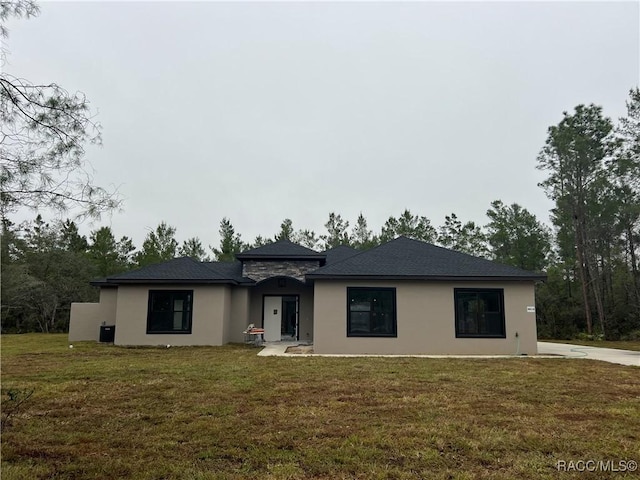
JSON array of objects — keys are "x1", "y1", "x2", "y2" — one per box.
[{"x1": 538, "y1": 88, "x2": 640, "y2": 338}]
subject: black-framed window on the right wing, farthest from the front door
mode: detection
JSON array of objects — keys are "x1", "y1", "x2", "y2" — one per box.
[{"x1": 454, "y1": 288, "x2": 506, "y2": 338}]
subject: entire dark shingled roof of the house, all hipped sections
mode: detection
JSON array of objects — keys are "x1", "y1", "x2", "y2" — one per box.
[{"x1": 91, "y1": 237, "x2": 546, "y2": 287}]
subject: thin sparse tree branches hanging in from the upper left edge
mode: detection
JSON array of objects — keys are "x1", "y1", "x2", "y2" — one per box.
[{"x1": 0, "y1": 0, "x2": 121, "y2": 217}]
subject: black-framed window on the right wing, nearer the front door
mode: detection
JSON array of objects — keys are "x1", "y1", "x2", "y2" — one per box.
[{"x1": 347, "y1": 287, "x2": 397, "y2": 337}]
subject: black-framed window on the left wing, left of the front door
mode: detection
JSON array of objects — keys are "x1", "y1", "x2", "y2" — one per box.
[{"x1": 147, "y1": 290, "x2": 193, "y2": 333}]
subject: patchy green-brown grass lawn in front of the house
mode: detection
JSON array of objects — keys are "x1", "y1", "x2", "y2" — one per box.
[{"x1": 2, "y1": 334, "x2": 640, "y2": 480}]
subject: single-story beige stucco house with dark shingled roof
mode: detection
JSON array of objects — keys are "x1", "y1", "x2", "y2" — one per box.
[{"x1": 69, "y1": 237, "x2": 545, "y2": 355}]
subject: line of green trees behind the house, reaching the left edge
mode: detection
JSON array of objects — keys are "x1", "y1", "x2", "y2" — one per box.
[{"x1": 1, "y1": 201, "x2": 549, "y2": 332}]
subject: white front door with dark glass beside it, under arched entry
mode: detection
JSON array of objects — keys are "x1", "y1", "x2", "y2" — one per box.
[{"x1": 262, "y1": 295, "x2": 298, "y2": 342}]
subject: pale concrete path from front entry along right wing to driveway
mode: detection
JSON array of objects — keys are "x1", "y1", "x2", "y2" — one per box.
[{"x1": 258, "y1": 342, "x2": 640, "y2": 366}]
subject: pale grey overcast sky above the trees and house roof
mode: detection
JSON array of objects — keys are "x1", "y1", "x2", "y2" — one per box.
[{"x1": 5, "y1": 2, "x2": 640, "y2": 251}]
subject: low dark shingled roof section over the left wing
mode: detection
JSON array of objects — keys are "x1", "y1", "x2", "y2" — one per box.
[{"x1": 91, "y1": 257, "x2": 249, "y2": 285}]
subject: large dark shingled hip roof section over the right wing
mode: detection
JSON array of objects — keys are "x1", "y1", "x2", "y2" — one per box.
[{"x1": 307, "y1": 237, "x2": 546, "y2": 280}]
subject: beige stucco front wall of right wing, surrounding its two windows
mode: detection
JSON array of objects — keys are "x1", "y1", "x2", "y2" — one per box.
[{"x1": 314, "y1": 280, "x2": 537, "y2": 355}]
